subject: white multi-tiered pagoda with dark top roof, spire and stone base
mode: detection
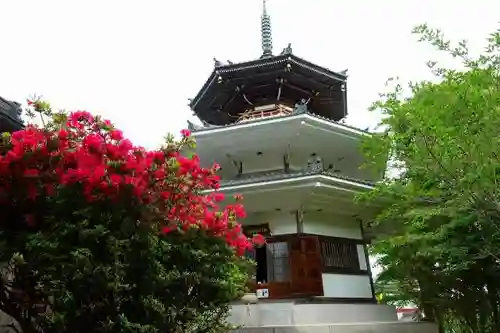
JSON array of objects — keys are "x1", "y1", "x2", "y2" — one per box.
[{"x1": 188, "y1": 0, "x2": 435, "y2": 333}]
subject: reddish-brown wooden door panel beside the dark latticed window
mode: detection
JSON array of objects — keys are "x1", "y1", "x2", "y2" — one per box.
[{"x1": 289, "y1": 236, "x2": 323, "y2": 296}]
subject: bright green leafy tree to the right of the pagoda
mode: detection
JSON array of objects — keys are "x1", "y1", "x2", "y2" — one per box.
[{"x1": 364, "y1": 25, "x2": 500, "y2": 332}]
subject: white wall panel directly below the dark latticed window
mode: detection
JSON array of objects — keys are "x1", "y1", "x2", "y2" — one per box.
[{"x1": 321, "y1": 273, "x2": 372, "y2": 298}]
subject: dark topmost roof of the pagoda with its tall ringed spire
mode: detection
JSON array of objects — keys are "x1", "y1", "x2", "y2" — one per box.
[{"x1": 190, "y1": 0, "x2": 347, "y2": 125}]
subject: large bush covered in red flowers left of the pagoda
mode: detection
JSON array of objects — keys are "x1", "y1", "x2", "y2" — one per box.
[{"x1": 0, "y1": 100, "x2": 258, "y2": 333}]
